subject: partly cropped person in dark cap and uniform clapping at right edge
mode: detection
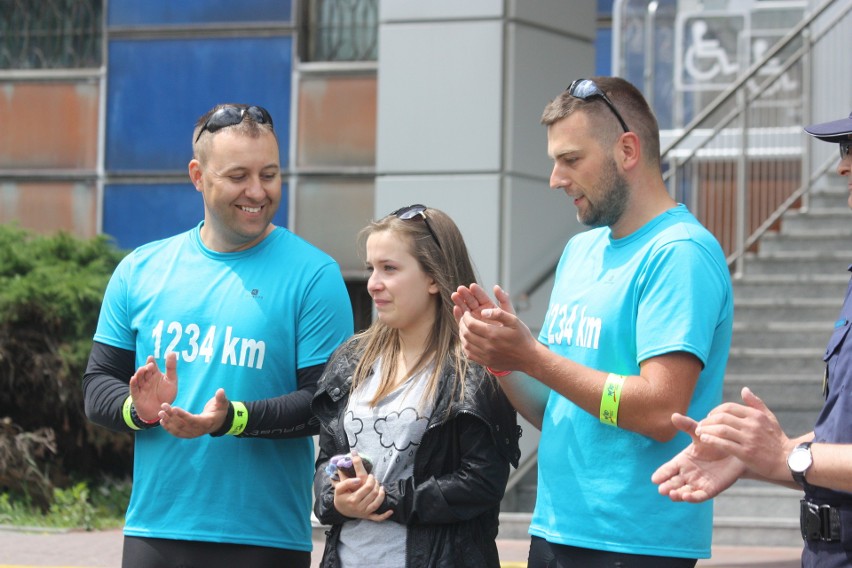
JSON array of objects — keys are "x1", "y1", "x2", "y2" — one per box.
[{"x1": 653, "y1": 114, "x2": 852, "y2": 568}]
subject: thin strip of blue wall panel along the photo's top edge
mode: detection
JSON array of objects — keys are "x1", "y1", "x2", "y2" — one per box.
[{"x1": 107, "y1": 0, "x2": 293, "y2": 26}]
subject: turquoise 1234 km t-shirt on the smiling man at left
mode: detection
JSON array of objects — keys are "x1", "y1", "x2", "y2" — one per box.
[{"x1": 95, "y1": 225, "x2": 353, "y2": 551}]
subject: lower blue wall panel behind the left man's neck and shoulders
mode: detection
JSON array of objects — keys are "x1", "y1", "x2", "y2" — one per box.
[{"x1": 103, "y1": 184, "x2": 288, "y2": 249}]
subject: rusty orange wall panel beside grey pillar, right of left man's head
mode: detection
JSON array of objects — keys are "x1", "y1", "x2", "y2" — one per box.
[{"x1": 296, "y1": 74, "x2": 376, "y2": 168}]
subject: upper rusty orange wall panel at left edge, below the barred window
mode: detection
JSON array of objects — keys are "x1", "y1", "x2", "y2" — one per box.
[{"x1": 0, "y1": 81, "x2": 98, "y2": 170}]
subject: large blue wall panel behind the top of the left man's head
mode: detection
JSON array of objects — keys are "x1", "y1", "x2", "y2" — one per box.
[{"x1": 105, "y1": 36, "x2": 293, "y2": 174}]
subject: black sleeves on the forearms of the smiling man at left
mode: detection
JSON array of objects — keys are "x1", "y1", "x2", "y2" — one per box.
[{"x1": 83, "y1": 341, "x2": 325, "y2": 438}]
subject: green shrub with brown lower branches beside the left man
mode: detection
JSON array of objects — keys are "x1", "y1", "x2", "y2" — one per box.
[{"x1": 0, "y1": 225, "x2": 132, "y2": 516}]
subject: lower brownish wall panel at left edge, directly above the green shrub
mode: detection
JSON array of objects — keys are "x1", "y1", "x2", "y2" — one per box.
[{"x1": 0, "y1": 182, "x2": 97, "y2": 238}]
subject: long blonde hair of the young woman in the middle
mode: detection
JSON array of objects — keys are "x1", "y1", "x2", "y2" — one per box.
[{"x1": 352, "y1": 208, "x2": 476, "y2": 406}]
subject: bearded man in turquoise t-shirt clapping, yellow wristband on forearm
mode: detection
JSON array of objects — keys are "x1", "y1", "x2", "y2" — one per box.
[{"x1": 454, "y1": 77, "x2": 733, "y2": 568}]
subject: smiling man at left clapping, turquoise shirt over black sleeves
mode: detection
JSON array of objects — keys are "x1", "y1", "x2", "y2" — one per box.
[{"x1": 83, "y1": 105, "x2": 353, "y2": 568}]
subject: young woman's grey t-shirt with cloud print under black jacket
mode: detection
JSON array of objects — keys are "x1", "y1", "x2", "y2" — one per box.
[{"x1": 338, "y1": 362, "x2": 432, "y2": 568}]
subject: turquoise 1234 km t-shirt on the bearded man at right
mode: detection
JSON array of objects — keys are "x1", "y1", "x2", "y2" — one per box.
[{"x1": 530, "y1": 205, "x2": 733, "y2": 558}]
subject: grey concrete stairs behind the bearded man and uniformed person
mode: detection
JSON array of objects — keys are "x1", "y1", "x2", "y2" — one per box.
[{"x1": 713, "y1": 174, "x2": 852, "y2": 546}]
